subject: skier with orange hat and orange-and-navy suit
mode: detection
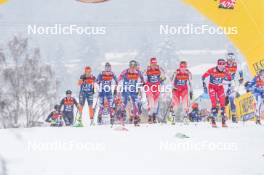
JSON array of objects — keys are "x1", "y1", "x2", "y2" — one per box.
[{"x1": 79, "y1": 66, "x2": 96, "y2": 125}]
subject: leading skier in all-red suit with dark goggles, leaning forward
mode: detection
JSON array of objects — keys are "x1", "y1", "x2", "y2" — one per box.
[{"x1": 202, "y1": 59, "x2": 231, "y2": 127}]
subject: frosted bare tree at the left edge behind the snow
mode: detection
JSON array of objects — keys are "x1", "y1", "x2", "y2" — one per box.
[{"x1": 0, "y1": 37, "x2": 57, "y2": 128}]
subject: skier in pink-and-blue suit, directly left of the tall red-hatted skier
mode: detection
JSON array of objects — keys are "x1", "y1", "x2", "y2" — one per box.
[{"x1": 118, "y1": 60, "x2": 144, "y2": 126}]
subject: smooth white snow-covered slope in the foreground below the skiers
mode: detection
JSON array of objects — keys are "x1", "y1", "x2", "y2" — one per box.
[{"x1": 0, "y1": 122, "x2": 264, "y2": 175}]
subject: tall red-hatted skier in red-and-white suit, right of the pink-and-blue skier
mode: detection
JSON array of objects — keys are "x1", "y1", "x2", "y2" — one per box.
[{"x1": 144, "y1": 58, "x2": 165, "y2": 123}]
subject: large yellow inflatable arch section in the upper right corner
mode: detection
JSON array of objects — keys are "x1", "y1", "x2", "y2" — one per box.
[{"x1": 184, "y1": 0, "x2": 264, "y2": 76}]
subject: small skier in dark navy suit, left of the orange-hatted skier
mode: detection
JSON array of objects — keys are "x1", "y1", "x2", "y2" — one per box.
[{"x1": 60, "y1": 90, "x2": 80, "y2": 126}]
